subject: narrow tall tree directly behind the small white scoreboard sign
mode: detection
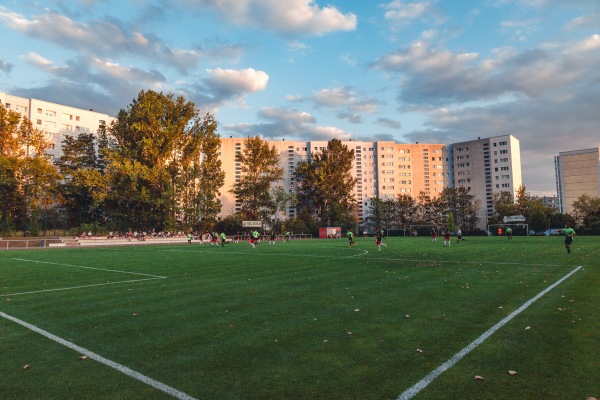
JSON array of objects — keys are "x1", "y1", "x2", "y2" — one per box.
[{"x1": 230, "y1": 136, "x2": 283, "y2": 221}]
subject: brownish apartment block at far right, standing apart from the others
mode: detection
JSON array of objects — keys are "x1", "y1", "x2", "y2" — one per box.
[{"x1": 554, "y1": 147, "x2": 600, "y2": 213}]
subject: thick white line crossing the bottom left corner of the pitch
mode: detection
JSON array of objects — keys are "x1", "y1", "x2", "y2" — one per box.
[{"x1": 0, "y1": 311, "x2": 196, "y2": 400}]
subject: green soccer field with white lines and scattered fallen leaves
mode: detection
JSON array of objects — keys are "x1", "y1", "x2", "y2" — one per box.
[{"x1": 0, "y1": 237, "x2": 600, "y2": 399}]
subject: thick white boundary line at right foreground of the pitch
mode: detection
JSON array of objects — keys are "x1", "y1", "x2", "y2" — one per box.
[{"x1": 397, "y1": 265, "x2": 582, "y2": 400}]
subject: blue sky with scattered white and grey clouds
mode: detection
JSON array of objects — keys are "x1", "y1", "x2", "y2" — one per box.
[{"x1": 0, "y1": 0, "x2": 600, "y2": 196}]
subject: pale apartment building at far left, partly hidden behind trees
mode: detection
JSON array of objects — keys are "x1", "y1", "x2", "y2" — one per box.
[{"x1": 0, "y1": 92, "x2": 114, "y2": 157}]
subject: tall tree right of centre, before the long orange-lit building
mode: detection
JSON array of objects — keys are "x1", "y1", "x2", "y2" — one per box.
[{"x1": 295, "y1": 139, "x2": 357, "y2": 228}]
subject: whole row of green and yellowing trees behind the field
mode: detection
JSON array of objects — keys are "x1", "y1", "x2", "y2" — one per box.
[{"x1": 0, "y1": 91, "x2": 600, "y2": 236}]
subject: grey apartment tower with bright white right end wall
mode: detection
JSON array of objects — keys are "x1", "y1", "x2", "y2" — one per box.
[{"x1": 445, "y1": 135, "x2": 523, "y2": 229}]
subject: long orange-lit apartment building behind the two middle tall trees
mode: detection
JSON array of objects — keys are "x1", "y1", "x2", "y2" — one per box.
[{"x1": 219, "y1": 137, "x2": 446, "y2": 220}]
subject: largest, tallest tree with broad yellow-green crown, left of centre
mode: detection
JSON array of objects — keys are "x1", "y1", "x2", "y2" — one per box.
[{"x1": 106, "y1": 91, "x2": 222, "y2": 229}]
